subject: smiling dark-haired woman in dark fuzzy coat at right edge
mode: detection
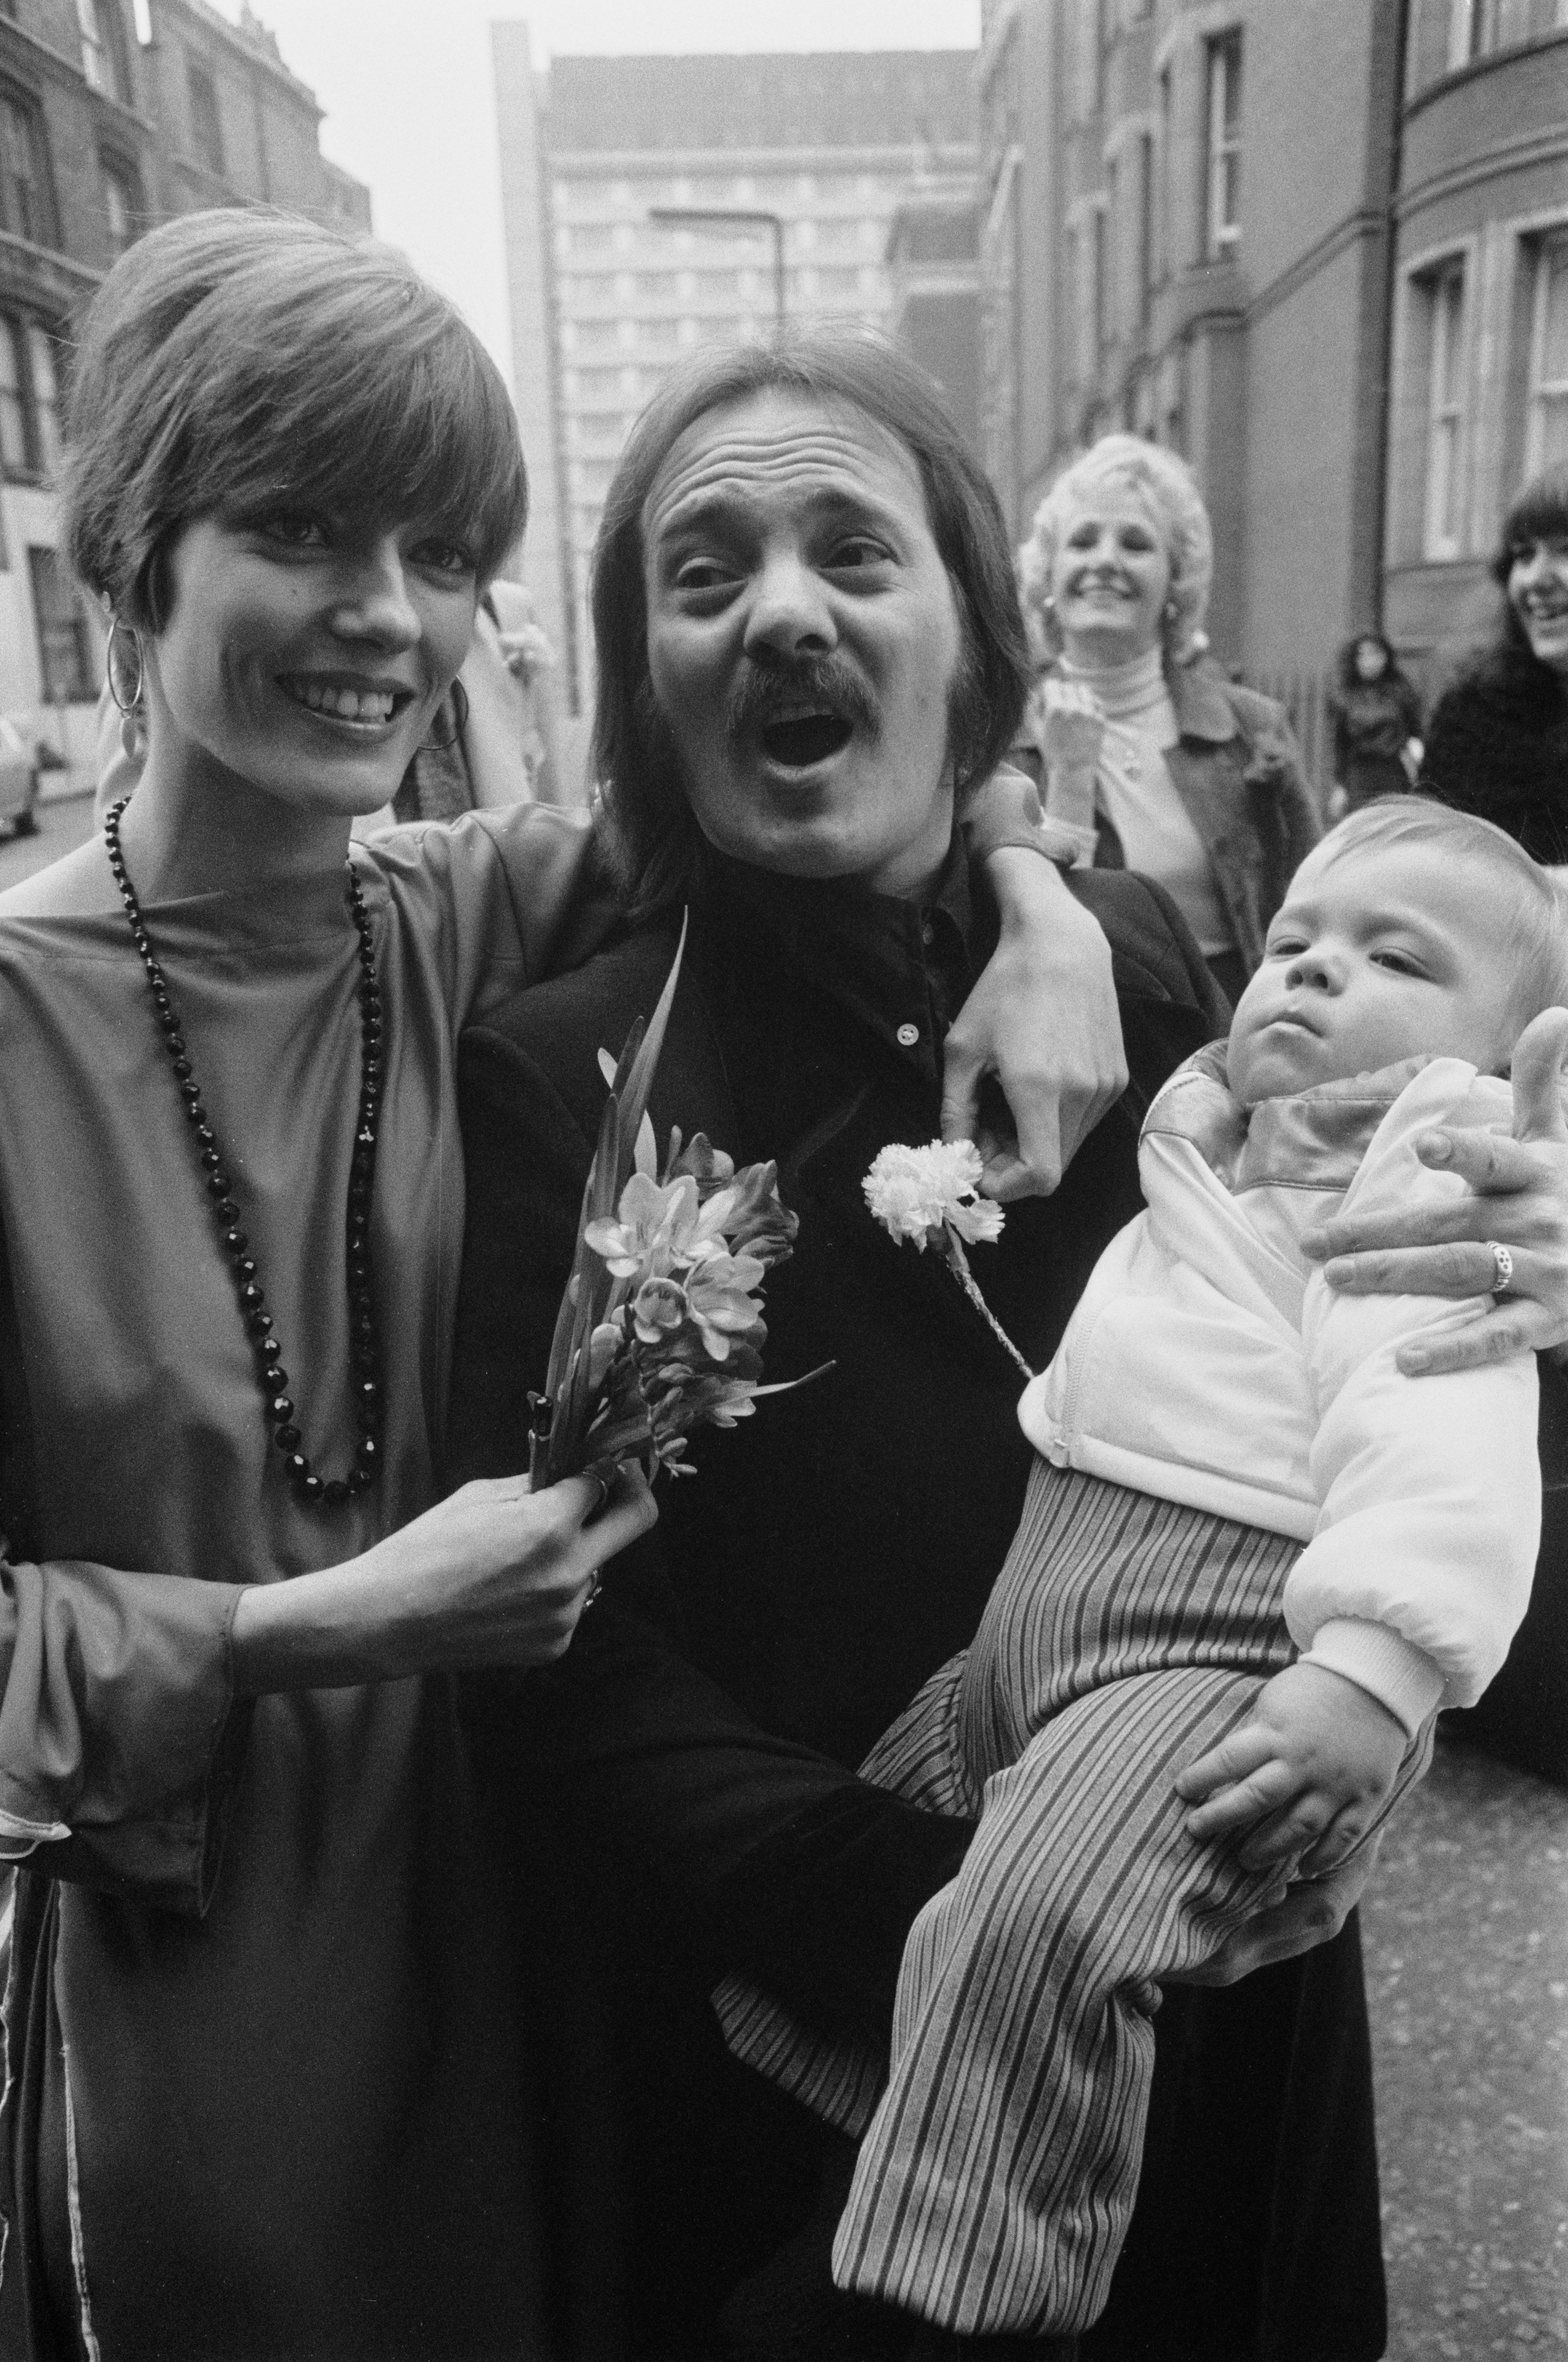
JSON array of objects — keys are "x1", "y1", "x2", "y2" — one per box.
[{"x1": 1424, "y1": 463, "x2": 1568, "y2": 867}]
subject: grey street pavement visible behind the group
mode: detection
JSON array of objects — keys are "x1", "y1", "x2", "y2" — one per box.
[{"x1": 0, "y1": 796, "x2": 1568, "y2": 2362}]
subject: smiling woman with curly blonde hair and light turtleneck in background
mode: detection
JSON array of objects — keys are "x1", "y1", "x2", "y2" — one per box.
[{"x1": 1018, "y1": 435, "x2": 1320, "y2": 1002}]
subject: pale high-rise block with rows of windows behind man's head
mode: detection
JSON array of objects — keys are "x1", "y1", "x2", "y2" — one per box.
[{"x1": 496, "y1": 43, "x2": 975, "y2": 701}]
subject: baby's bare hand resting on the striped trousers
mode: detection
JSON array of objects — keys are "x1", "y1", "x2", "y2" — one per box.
[{"x1": 1176, "y1": 1665, "x2": 1410, "y2": 1878}]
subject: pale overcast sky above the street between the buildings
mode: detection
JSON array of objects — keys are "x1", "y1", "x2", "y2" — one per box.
[{"x1": 217, "y1": 0, "x2": 980, "y2": 382}]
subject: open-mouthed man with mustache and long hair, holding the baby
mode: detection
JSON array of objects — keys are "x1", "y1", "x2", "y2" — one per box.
[{"x1": 451, "y1": 338, "x2": 1381, "y2": 2362}]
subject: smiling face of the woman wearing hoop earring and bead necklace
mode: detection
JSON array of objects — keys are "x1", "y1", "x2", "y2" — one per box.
[{"x1": 144, "y1": 510, "x2": 477, "y2": 815}]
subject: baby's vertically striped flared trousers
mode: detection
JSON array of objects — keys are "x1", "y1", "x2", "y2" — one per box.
[{"x1": 715, "y1": 1460, "x2": 1431, "y2": 2336}]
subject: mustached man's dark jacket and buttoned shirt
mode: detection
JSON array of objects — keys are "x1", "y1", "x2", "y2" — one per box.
[{"x1": 449, "y1": 864, "x2": 1381, "y2": 2362}]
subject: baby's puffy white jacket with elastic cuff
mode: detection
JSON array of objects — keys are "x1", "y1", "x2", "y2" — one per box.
[{"x1": 1018, "y1": 1042, "x2": 1540, "y2": 1736}]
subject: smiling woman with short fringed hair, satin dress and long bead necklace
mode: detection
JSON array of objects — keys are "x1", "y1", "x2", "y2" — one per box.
[{"x1": 0, "y1": 213, "x2": 654, "y2": 2362}]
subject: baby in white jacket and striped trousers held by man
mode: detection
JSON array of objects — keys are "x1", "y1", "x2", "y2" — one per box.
[{"x1": 715, "y1": 798, "x2": 1568, "y2": 2336}]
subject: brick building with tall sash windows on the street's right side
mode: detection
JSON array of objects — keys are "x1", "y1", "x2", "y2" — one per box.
[{"x1": 978, "y1": 0, "x2": 1568, "y2": 770}]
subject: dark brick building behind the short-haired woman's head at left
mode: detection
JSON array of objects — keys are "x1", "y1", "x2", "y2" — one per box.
[{"x1": 0, "y1": 0, "x2": 371, "y2": 784}]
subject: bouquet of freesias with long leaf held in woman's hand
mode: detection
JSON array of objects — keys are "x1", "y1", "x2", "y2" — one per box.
[{"x1": 529, "y1": 928, "x2": 819, "y2": 1486}]
